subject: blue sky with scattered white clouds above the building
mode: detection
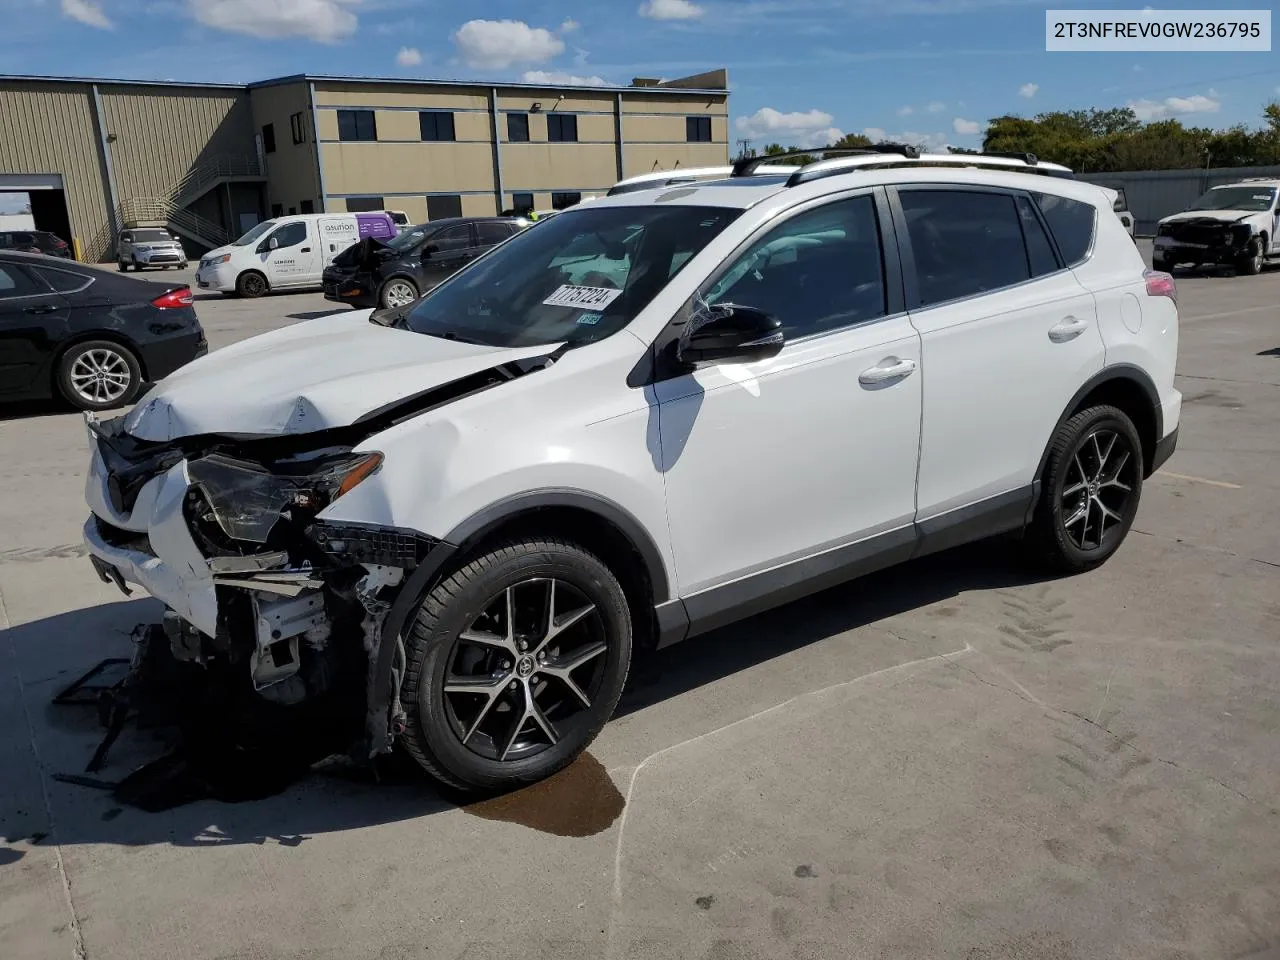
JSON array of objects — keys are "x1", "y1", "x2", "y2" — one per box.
[{"x1": 0, "y1": 0, "x2": 1280, "y2": 152}]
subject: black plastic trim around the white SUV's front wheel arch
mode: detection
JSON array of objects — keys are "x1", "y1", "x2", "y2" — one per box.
[{"x1": 367, "y1": 488, "x2": 684, "y2": 751}]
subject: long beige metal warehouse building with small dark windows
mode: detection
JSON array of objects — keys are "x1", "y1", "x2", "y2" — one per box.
[{"x1": 0, "y1": 70, "x2": 730, "y2": 260}]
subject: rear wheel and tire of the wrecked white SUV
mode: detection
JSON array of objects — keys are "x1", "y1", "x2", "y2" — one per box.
[{"x1": 1027, "y1": 406, "x2": 1144, "y2": 573}]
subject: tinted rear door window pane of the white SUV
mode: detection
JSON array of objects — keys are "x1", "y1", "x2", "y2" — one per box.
[{"x1": 899, "y1": 189, "x2": 1032, "y2": 307}]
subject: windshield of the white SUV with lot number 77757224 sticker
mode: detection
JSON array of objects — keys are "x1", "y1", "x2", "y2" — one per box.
[{"x1": 404, "y1": 206, "x2": 741, "y2": 347}]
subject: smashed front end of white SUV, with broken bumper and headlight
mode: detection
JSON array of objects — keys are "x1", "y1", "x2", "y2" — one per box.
[{"x1": 84, "y1": 417, "x2": 436, "y2": 756}]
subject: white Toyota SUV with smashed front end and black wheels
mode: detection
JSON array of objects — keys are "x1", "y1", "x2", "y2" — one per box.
[{"x1": 84, "y1": 155, "x2": 1181, "y2": 790}]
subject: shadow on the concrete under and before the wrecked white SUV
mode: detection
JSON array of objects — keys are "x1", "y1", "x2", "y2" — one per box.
[{"x1": 5, "y1": 541, "x2": 1036, "y2": 847}]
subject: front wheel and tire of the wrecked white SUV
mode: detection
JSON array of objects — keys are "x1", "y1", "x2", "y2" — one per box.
[{"x1": 401, "y1": 538, "x2": 631, "y2": 792}]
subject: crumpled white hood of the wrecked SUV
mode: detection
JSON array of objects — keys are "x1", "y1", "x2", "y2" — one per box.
[{"x1": 124, "y1": 310, "x2": 554, "y2": 442}]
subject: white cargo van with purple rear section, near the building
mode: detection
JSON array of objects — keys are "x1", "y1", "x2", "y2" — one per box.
[{"x1": 196, "y1": 211, "x2": 397, "y2": 297}]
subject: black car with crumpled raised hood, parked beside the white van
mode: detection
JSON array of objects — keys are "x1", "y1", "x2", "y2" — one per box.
[{"x1": 323, "y1": 216, "x2": 529, "y2": 307}]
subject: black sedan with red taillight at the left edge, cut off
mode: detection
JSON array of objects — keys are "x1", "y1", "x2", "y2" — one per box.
[{"x1": 0, "y1": 251, "x2": 209, "y2": 410}]
